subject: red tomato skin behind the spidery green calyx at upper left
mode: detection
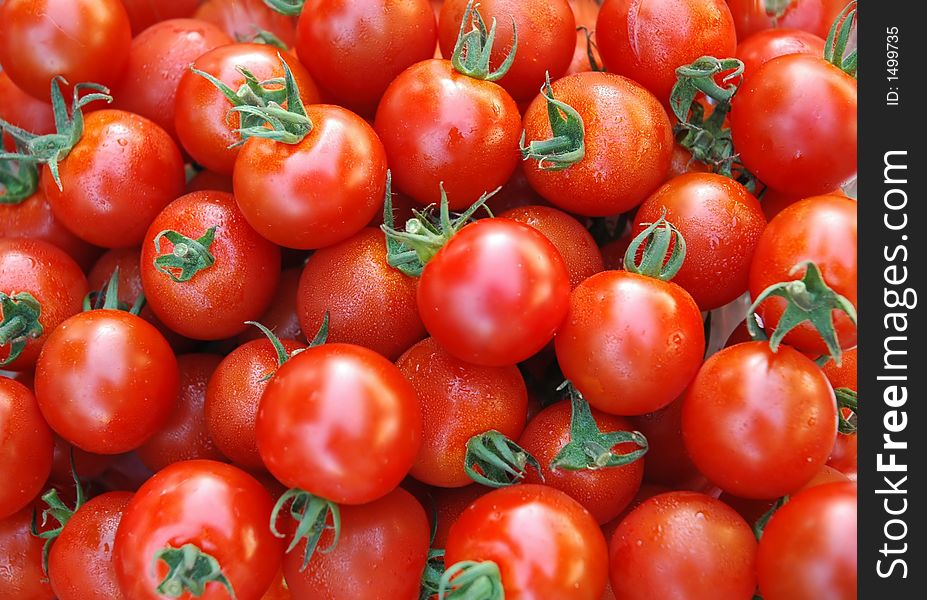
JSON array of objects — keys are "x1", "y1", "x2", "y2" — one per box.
[{"x1": 173, "y1": 43, "x2": 319, "y2": 175}]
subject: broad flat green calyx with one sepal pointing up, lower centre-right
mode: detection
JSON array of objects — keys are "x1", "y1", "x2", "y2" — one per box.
[{"x1": 550, "y1": 381, "x2": 648, "y2": 471}]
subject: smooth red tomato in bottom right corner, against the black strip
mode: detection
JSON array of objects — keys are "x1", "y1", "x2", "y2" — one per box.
[{"x1": 757, "y1": 482, "x2": 857, "y2": 600}]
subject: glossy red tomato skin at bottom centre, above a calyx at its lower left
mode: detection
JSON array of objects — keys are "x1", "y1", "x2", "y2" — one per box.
[{"x1": 445, "y1": 484, "x2": 608, "y2": 600}]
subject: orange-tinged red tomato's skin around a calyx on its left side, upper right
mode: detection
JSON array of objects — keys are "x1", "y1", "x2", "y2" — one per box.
[{"x1": 524, "y1": 72, "x2": 674, "y2": 217}]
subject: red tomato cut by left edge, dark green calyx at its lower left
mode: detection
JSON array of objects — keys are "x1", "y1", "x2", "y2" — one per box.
[{"x1": 0, "y1": 238, "x2": 87, "y2": 371}]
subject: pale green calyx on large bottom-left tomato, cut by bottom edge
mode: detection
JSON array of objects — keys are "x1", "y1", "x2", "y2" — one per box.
[{"x1": 152, "y1": 544, "x2": 235, "y2": 599}]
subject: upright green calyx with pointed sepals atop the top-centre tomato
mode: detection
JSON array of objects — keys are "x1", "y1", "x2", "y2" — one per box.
[{"x1": 451, "y1": 0, "x2": 518, "y2": 81}]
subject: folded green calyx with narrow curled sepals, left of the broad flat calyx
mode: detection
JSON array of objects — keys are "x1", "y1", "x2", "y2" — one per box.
[{"x1": 464, "y1": 429, "x2": 544, "y2": 488}]
